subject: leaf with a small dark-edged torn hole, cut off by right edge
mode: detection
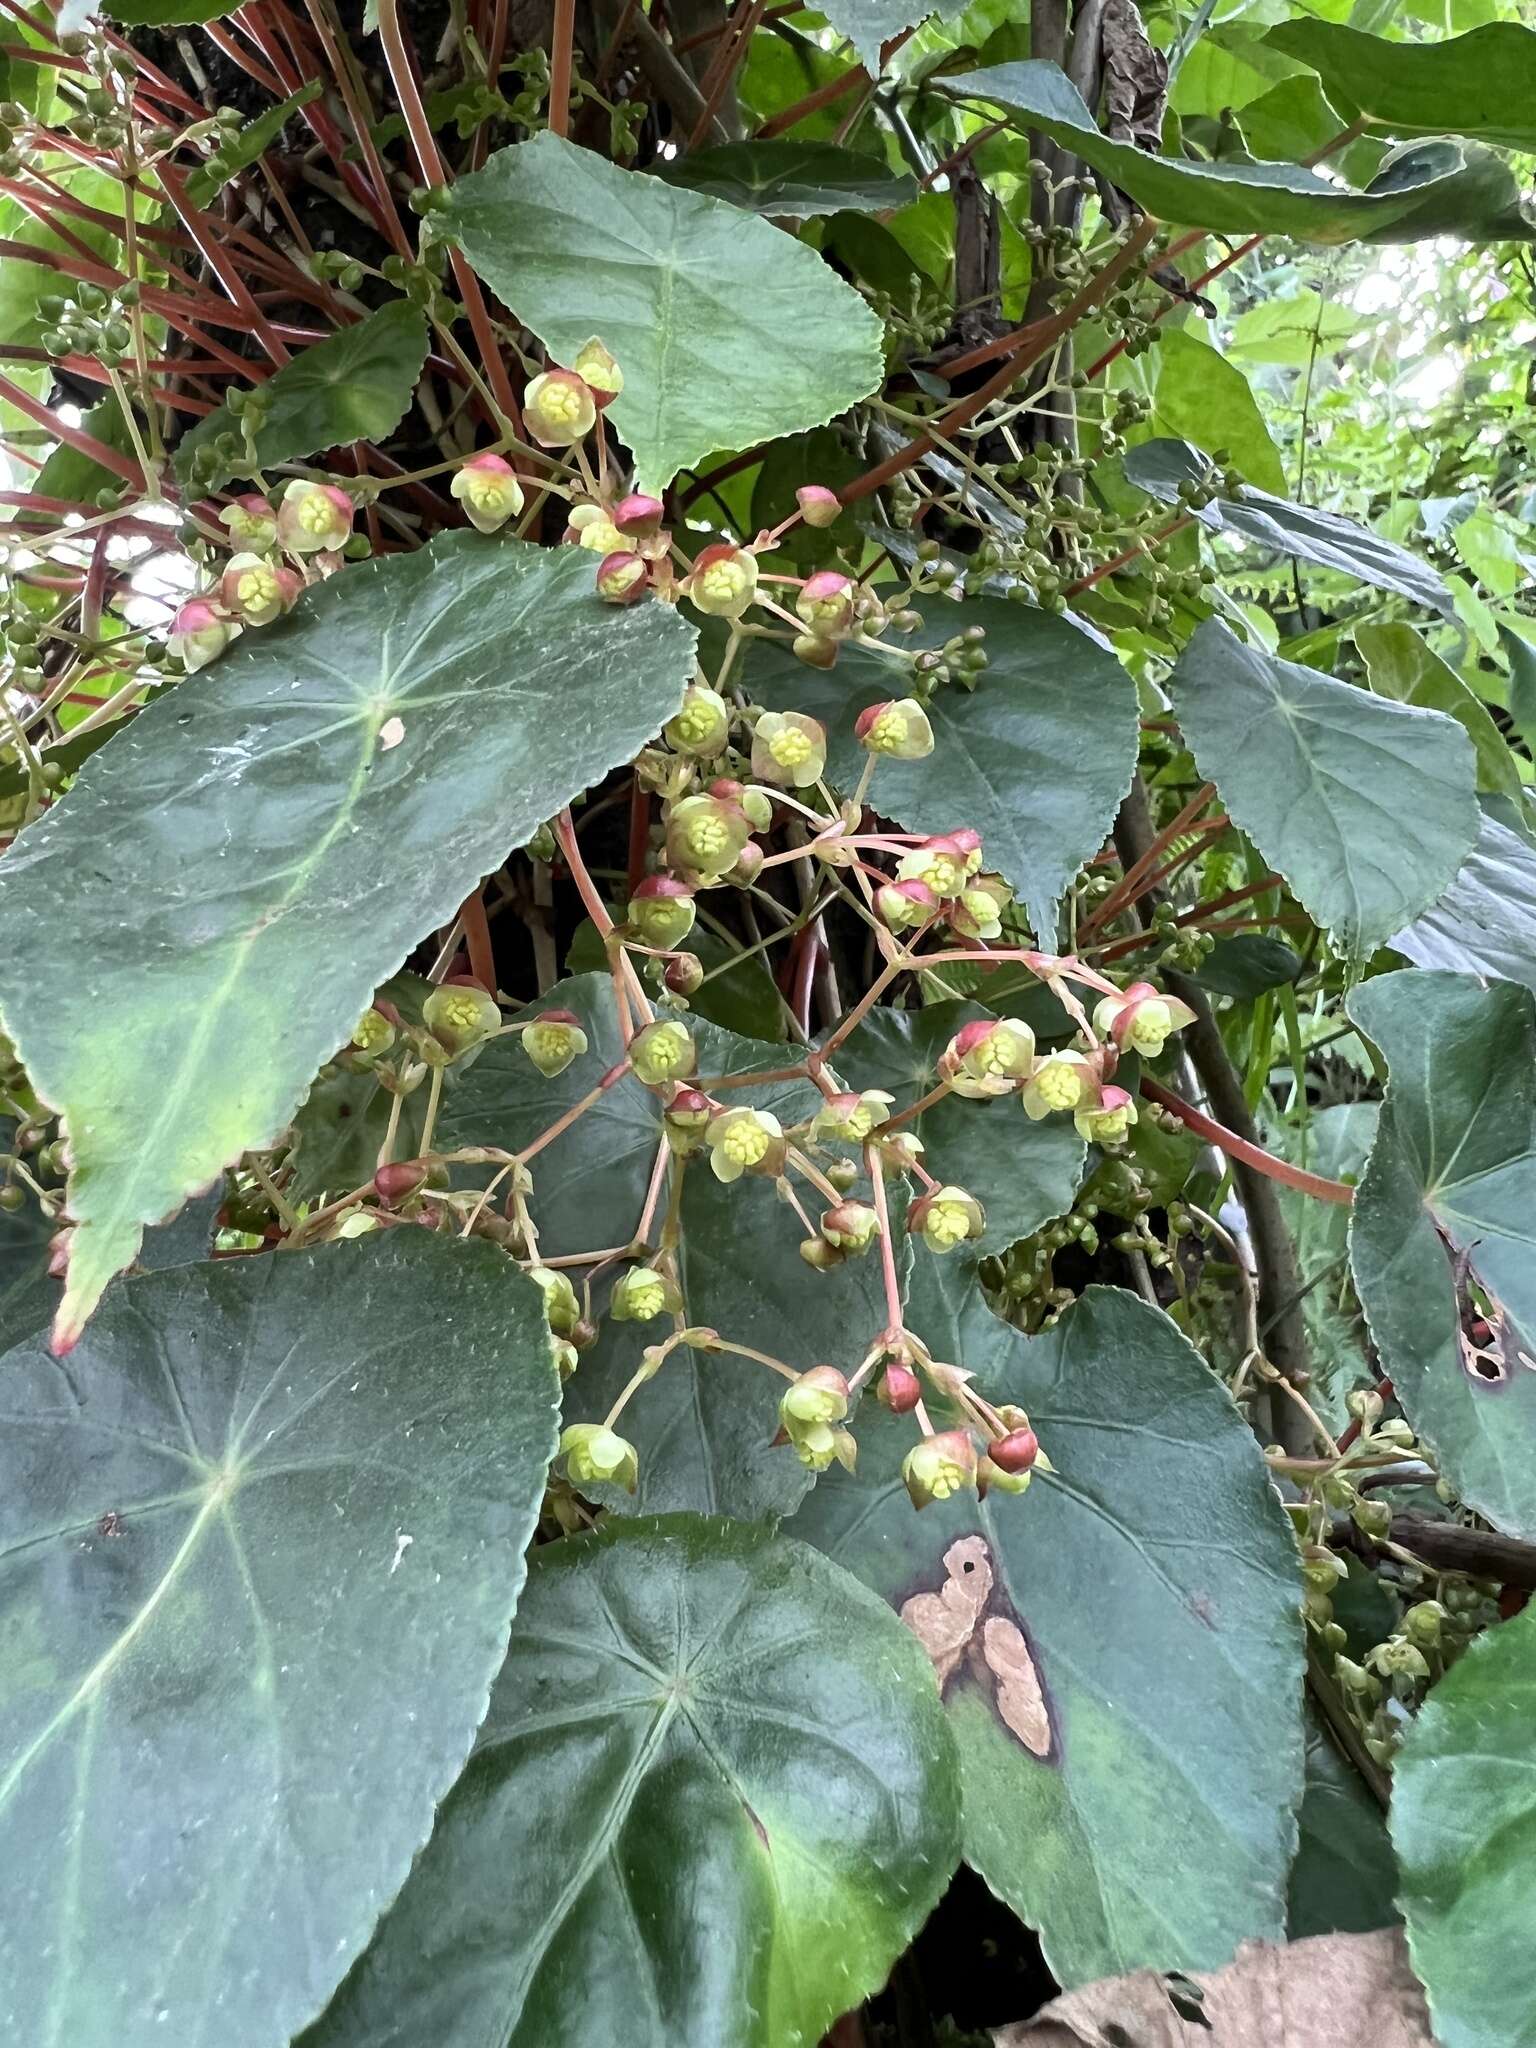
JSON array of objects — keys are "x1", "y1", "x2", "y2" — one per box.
[{"x1": 1350, "y1": 969, "x2": 1536, "y2": 1538}]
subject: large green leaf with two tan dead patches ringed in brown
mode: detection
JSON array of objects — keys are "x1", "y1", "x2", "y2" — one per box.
[{"x1": 791, "y1": 1260, "x2": 1303, "y2": 1985}]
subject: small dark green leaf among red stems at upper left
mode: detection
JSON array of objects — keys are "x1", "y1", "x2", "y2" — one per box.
[{"x1": 176, "y1": 301, "x2": 426, "y2": 483}]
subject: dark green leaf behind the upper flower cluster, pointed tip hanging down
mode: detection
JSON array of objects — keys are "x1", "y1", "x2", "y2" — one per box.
[{"x1": 745, "y1": 598, "x2": 1137, "y2": 944}]
